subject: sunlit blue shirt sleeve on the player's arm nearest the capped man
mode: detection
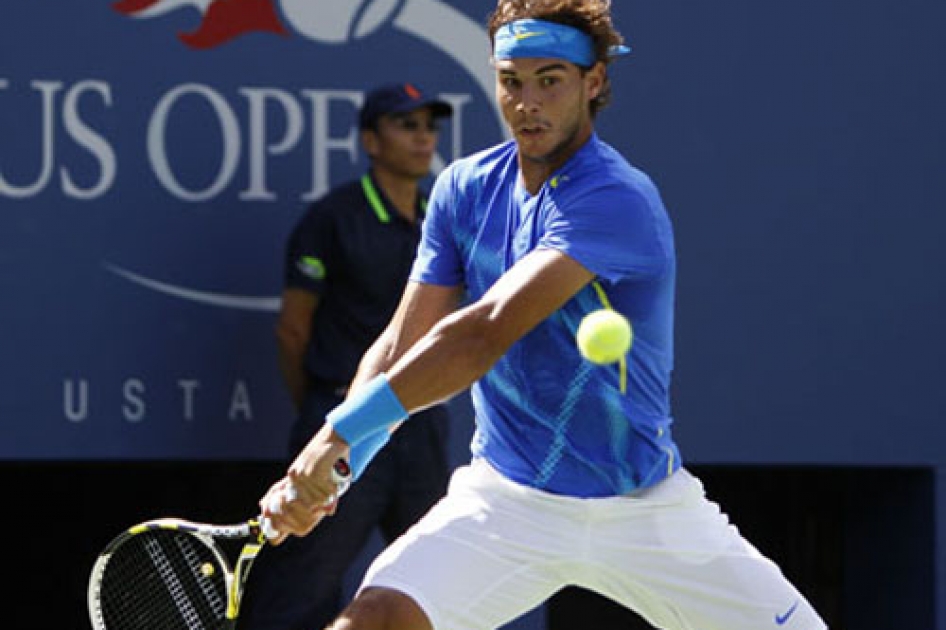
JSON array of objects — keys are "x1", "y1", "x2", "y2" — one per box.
[{"x1": 410, "y1": 165, "x2": 463, "y2": 287}]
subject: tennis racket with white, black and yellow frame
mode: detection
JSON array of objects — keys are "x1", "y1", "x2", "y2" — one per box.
[{"x1": 88, "y1": 460, "x2": 351, "y2": 630}]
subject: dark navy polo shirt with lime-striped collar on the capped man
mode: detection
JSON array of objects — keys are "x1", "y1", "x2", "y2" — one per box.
[{"x1": 284, "y1": 174, "x2": 426, "y2": 385}]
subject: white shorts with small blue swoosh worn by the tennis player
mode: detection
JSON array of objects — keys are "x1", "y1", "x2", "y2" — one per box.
[{"x1": 361, "y1": 460, "x2": 827, "y2": 630}]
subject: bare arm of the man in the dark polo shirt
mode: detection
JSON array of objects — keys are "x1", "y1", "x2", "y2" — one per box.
[{"x1": 276, "y1": 288, "x2": 319, "y2": 409}]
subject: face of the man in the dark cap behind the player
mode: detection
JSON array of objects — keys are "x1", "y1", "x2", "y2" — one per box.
[{"x1": 362, "y1": 107, "x2": 438, "y2": 179}]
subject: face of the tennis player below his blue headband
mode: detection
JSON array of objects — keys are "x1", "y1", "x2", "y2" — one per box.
[{"x1": 495, "y1": 58, "x2": 603, "y2": 169}]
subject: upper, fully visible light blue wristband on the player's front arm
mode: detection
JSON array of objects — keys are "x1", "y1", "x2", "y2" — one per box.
[{"x1": 326, "y1": 374, "x2": 408, "y2": 447}]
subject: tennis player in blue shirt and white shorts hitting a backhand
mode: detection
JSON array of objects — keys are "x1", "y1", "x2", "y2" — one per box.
[{"x1": 261, "y1": 0, "x2": 826, "y2": 630}]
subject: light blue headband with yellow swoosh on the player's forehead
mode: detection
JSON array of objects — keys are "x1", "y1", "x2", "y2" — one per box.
[{"x1": 493, "y1": 18, "x2": 631, "y2": 68}]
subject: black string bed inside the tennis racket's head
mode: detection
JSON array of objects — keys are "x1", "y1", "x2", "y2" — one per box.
[{"x1": 101, "y1": 530, "x2": 227, "y2": 630}]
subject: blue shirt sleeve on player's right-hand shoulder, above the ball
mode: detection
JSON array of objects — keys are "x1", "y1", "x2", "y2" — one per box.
[{"x1": 539, "y1": 180, "x2": 673, "y2": 282}]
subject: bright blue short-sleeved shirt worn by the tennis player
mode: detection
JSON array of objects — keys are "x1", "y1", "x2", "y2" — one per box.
[{"x1": 411, "y1": 135, "x2": 680, "y2": 497}]
